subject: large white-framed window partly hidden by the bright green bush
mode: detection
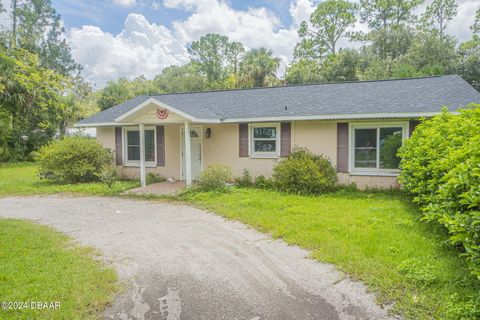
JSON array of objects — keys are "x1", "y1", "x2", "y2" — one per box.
[{"x1": 349, "y1": 122, "x2": 408, "y2": 175}]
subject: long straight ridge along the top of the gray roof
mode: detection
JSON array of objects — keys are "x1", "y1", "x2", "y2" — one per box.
[{"x1": 145, "y1": 74, "x2": 450, "y2": 97}]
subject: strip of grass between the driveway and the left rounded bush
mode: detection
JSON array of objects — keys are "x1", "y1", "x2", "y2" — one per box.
[{"x1": 0, "y1": 163, "x2": 140, "y2": 196}]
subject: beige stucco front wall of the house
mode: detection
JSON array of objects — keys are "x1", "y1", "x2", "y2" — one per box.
[{"x1": 97, "y1": 121, "x2": 399, "y2": 189}]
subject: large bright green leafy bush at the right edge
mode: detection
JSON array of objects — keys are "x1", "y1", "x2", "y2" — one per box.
[{"x1": 399, "y1": 105, "x2": 480, "y2": 279}]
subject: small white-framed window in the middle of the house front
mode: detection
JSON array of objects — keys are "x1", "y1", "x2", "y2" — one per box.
[{"x1": 249, "y1": 123, "x2": 280, "y2": 158}]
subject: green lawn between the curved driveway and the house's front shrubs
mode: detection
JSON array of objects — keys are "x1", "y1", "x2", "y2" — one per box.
[{"x1": 182, "y1": 189, "x2": 480, "y2": 319}]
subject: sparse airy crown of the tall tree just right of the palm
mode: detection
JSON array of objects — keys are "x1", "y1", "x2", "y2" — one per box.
[{"x1": 296, "y1": 0, "x2": 357, "y2": 58}]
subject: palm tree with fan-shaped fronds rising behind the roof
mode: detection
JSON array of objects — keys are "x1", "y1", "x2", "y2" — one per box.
[{"x1": 240, "y1": 48, "x2": 280, "y2": 87}]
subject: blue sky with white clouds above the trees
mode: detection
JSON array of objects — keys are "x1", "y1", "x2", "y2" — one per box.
[{"x1": 7, "y1": 0, "x2": 480, "y2": 88}]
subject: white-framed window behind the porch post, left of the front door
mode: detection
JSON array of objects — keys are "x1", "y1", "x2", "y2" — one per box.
[{"x1": 123, "y1": 127, "x2": 157, "y2": 166}]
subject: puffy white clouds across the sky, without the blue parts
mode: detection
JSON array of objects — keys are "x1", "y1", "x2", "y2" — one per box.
[{"x1": 67, "y1": 0, "x2": 480, "y2": 87}]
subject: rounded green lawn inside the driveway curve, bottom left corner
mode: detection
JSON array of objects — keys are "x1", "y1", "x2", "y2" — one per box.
[{"x1": 0, "y1": 219, "x2": 118, "y2": 320}]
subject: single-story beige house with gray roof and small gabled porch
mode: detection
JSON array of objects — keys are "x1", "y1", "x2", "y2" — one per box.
[{"x1": 76, "y1": 75, "x2": 480, "y2": 188}]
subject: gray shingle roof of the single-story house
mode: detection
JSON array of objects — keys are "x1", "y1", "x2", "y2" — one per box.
[{"x1": 78, "y1": 75, "x2": 480, "y2": 126}]
